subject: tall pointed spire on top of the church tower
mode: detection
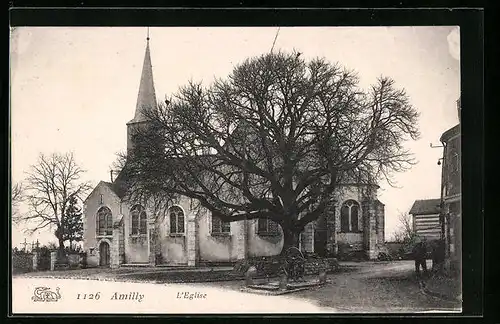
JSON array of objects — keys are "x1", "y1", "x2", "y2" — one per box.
[{"x1": 129, "y1": 37, "x2": 157, "y2": 123}]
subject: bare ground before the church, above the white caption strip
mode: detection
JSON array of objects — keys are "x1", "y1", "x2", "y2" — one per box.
[{"x1": 14, "y1": 261, "x2": 461, "y2": 313}]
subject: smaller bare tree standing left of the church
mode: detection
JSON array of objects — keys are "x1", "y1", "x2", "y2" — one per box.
[{"x1": 13, "y1": 153, "x2": 91, "y2": 251}]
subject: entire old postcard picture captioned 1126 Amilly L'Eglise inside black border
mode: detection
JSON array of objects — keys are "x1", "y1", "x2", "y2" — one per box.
[{"x1": 9, "y1": 25, "x2": 467, "y2": 314}]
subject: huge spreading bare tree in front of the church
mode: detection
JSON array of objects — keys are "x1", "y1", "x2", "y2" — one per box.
[{"x1": 120, "y1": 52, "x2": 419, "y2": 253}]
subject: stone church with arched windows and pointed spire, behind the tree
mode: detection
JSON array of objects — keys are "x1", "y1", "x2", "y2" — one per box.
[{"x1": 83, "y1": 37, "x2": 384, "y2": 268}]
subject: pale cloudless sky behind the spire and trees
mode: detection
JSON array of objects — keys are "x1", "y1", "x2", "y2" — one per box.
[{"x1": 10, "y1": 26, "x2": 460, "y2": 246}]
